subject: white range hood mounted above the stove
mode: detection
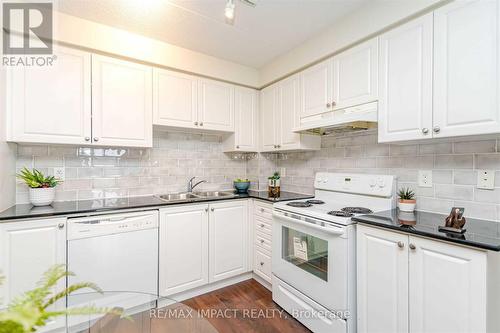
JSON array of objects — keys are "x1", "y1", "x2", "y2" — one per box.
[{"x1": 294, "y1": 102, "x2": 378, "y2": 135}]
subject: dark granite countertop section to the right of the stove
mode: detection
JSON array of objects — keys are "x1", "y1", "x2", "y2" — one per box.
[{"x1": 352, "y1": 209, "x2": 500, "y2": 252}]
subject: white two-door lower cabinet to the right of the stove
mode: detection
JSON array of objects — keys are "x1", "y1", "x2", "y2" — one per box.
[{"x1": 357, "y1": 225, "x2": 487, "y2": 332}]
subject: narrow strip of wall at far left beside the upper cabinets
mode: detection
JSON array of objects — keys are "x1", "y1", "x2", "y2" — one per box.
[{"x1": 0, "y1": 69, "x2": 17, "y2": 211}]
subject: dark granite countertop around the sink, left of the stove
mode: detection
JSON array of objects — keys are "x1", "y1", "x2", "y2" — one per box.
[{"x1": 0, "y1": 191, "x2": 314, "y2": 222}]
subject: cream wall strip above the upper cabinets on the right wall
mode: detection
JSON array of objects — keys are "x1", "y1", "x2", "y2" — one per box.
[{"x1": 260, "y1": 0, "x2": 448, "y2": 86}]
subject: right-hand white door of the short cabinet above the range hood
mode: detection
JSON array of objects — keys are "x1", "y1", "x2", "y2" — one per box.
[{"x1": 333, "y1": 38, "x2": 378, "y2": 109}]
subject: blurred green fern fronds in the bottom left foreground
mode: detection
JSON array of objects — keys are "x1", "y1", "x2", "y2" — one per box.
[{"x1": 0, "y1": 265, "x2": 123, "y2": 333}]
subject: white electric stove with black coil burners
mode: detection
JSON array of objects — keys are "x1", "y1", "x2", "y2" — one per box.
[{"x1": 272, "y1": 173, "x2": 396, "y2": 333}]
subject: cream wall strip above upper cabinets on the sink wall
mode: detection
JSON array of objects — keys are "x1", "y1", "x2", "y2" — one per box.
[{"x1": 50, "y1": 12, "x2": 259, "y2": 87}]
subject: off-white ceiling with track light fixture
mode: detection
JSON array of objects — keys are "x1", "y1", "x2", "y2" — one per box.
[{"x1": 56, "y1": 0, "x2": 368, "y2": 68}]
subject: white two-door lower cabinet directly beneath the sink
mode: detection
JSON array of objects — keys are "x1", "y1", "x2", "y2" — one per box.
[{"x1": 159, "y1": 200, "x2": 248, "y2": 296}]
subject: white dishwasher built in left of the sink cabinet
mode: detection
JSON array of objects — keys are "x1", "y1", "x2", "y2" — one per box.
[{"x1": 67, "y1": 211, "x2": 158, "y2": 326}]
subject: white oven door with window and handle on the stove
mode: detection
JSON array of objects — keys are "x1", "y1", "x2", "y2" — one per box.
[{"x1": 272, "y1": 210, "x2": 352, "y2": 311}]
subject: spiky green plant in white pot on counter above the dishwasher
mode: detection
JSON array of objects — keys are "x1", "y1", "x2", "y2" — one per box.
[{"x1": 16, "y1": 168, "x2": 61, "y2": 206}]
